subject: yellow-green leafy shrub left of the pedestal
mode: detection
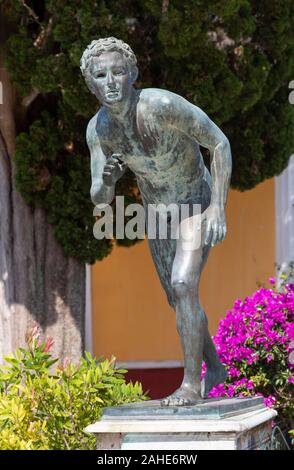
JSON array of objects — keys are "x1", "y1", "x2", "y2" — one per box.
[{"x1": 0, "y1": 326, "x2": 146, "y2": 450}]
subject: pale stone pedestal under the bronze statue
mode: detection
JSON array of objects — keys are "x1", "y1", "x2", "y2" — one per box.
[{"x1": 85, "y1": 398, "x2": 277, "y2": 450}]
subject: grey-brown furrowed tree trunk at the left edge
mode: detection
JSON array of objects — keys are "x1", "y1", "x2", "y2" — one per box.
[{"x1": 0, "y1": 133, "x2": 85, "y2": 360}]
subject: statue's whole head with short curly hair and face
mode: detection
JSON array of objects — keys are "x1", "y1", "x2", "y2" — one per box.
[{"x1": 81, "y1": 37, "x2": 138, "y2": 105}]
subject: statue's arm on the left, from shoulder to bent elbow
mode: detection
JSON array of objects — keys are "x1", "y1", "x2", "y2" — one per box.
[{"x1": 86, "y1": 115, "x2": 115, "y2": 205}]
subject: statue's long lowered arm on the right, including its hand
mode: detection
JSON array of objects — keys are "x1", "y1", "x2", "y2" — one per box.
[{"x1": 173, "y1": 99, "x2": 232, "y2": 246}]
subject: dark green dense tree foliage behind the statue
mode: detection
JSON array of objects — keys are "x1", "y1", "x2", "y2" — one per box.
[{"x1": 2, "y1": 0, "x2": 294, "y2": 263}]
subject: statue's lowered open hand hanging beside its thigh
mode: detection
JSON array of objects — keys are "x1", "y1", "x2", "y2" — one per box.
[{"x1": 202, "y1": 204, "x2": 227, "y2": 246}]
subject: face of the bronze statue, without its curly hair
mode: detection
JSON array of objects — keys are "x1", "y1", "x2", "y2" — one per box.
[{"x1": 91, "y1": 51, "x2": 133, "y2": 106}]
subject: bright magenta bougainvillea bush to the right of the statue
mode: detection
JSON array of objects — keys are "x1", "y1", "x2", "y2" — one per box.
[{"x1": 202, "y1": 278, "x2": 294, "y2": 406}]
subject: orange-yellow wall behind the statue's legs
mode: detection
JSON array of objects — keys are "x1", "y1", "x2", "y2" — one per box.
[{"x1": 92, "y1": 179, "x2": 275, "y2": 361}]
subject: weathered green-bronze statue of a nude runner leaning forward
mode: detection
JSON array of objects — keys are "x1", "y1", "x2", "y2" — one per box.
[{"x1": 81, "y1": 37, "x2": 232, "y2": 406}]
